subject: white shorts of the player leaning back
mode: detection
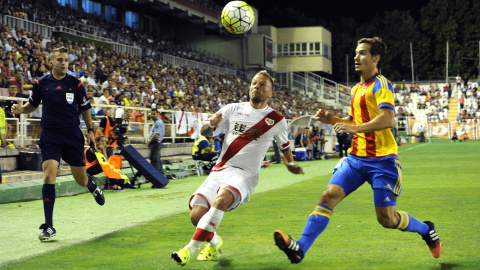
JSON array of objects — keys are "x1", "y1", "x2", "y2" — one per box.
[{"x1": 190, "y1": 167, "x2": 258, "y2": 211}]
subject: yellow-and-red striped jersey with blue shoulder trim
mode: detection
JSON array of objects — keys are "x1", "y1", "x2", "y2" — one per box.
[{"x1": 348, "y1": 74, "x2": 398, "y2": 158}]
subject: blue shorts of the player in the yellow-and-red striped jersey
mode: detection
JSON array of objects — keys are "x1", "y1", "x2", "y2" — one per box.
[{"x1": 328, "y1": 154, "x2": 402, "y2": 206}]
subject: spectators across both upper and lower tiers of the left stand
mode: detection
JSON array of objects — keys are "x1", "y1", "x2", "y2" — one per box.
[{"x1": 0, "y1": 0, "x2": 336, "y2": 128}]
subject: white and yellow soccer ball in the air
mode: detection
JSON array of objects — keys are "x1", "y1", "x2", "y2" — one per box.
[{"x1": 221, "y1": 1, "x2": 255, "y2": 34}]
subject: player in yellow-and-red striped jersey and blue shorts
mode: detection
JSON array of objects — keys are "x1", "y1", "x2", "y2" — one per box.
[{"x1": 274, "y1": 37, "x2": 442, "y2": 263}]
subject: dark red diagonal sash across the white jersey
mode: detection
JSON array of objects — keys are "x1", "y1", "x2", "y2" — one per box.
[{"x1": 215, "y1": 111, "x2": 283, "y2": 169}]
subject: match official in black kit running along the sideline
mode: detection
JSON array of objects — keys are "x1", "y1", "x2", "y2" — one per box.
[{"x1": 12, "y1": 47, "x2": 105, "y2": 241}]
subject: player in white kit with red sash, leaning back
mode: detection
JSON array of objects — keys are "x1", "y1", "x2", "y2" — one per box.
[{"x1": 172, "y1": 70, "x2": 303, "y2": 266}]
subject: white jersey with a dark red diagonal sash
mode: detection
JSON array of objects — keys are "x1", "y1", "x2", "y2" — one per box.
[{"x1": 212, "y1": 102, "x2": 289, "y2": 179}]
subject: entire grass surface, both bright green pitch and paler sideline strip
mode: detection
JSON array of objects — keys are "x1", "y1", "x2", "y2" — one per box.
[{"x1": 0, "y1": 139, "x2": 480, "y2": 269}]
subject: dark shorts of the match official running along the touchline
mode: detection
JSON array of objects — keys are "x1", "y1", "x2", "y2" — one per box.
[{"x1": 38, "y1": 127, "x2": 85, "y2": 166}]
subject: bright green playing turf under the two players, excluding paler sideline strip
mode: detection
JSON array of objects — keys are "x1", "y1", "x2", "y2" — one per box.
[{"x1": 0, "y1": 140, "x2": 480, "y2": 269}]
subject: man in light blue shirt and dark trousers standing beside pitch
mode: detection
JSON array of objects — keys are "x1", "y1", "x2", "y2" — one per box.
[{"x1": 147, "y1": 109, "x2": 165, "y2": 174}]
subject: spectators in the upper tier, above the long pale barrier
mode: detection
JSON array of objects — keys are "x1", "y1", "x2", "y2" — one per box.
[{"x1": 0, "y1": 0, "x2": 233, "y2": 69}]
